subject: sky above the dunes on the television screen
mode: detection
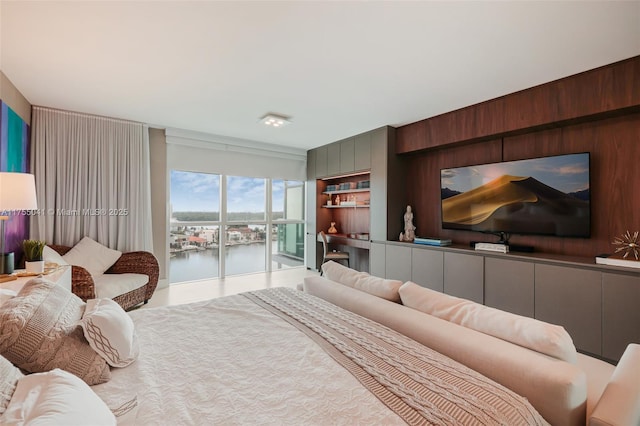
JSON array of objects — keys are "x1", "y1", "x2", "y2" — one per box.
[{"x1": 440, "y1": 153, "x2": 589, "y2": 193}]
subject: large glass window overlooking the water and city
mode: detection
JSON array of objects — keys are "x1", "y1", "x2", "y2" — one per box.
[{"x1": 169, "y1": 170, "x2": 304, "y2": 283}]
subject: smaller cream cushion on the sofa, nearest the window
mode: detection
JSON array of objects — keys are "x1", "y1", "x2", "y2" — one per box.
[{"x1": 322, "y1": 260, "x2": 402, "y2": 302}]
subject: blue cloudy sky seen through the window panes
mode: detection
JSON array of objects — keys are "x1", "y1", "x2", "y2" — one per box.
[{"x1": 170, "y1": 170, "x2": 292, "y2": 212}]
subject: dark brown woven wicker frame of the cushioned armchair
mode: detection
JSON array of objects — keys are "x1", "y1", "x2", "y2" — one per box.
[{"x1": 49, "y1": 244, "x2": 160, "y2": 310}]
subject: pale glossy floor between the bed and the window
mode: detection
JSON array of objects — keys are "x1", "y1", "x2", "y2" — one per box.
[{"x1": 142, "y1": 267, "x2": 319, "y2": 309}]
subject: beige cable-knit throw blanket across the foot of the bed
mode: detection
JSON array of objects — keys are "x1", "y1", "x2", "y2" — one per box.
[{"x1": 244, "y1": 288, "x2": 547, "y2": 425}]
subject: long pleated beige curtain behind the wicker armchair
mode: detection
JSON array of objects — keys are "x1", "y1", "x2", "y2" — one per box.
[{"x1": 31, "y1": 107, "x2": 153, "y2": 252}]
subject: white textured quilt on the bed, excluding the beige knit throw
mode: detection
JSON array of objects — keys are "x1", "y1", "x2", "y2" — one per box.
[{"x1": 93, "y1": 295, "x2": 405, "y2": 425}]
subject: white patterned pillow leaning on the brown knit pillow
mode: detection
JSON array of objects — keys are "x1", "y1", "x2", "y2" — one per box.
[{"x1": 80, "y1": 299, "x2": 140, "y2": 367}]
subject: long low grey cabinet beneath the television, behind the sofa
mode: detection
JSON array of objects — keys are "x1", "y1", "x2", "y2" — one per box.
[{"x1": 369, "y1": 240, "x2": 640, "y2": 362}]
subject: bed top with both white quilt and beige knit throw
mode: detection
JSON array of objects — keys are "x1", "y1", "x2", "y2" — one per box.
[{"x1": 93, "y1": 288, "x2": 546, "y2": 425}]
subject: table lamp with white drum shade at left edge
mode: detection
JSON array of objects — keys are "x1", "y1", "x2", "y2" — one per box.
[{"x1": 0, "y1": 172, "x2": 38, "y2": 274}]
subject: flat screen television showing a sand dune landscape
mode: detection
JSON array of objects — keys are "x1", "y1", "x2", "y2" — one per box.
[{"x1": 440, "y1": 152, "x2": 591, "y2": 242}]
